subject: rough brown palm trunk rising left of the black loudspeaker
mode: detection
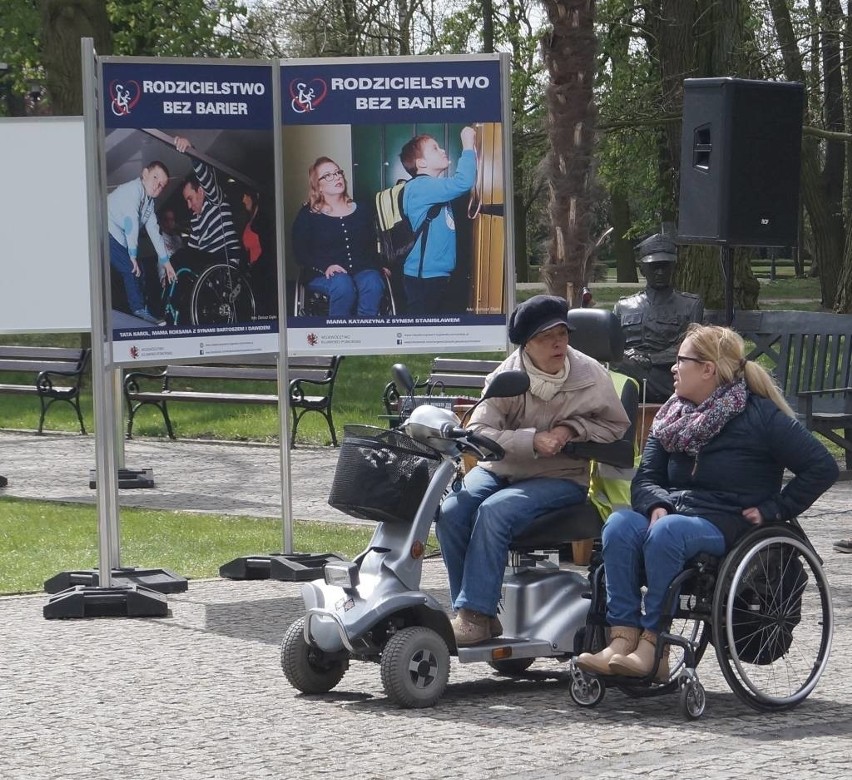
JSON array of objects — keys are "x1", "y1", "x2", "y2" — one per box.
[{"x1": 542, "y1": 0, "x2": 597, "y2": 306}]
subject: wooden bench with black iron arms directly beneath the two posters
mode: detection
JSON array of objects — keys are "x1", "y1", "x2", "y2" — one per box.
[{"x1": 124, "y1": 355, "x2": 343, "y2": 447}]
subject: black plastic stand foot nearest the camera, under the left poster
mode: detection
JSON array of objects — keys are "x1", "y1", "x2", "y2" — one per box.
[{"x1": 43, "y1": 585, "x2": 169, "y2": 620}]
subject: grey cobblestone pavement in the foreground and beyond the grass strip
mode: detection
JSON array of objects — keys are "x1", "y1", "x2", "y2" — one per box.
[{"x1": 0, "y1": 433, "x2": 852, "y2": 780}]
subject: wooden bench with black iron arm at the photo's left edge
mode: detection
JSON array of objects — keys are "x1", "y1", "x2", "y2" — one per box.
[{"x1": 0, "y1": 346, "x2": 91, "y2": 434}]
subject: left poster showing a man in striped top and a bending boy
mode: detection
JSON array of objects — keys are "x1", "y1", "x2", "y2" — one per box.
[{"x1": 100, "y1": 58, "x2": 278, "y2": 364}]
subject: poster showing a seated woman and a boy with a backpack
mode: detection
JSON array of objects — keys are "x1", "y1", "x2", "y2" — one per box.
[{"x1": 280, "y1": 55, "x2": 514, "y2": 354}]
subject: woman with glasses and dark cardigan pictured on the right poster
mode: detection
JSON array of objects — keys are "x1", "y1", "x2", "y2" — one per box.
[{"x1": 293, "y1": 157, "x2": 385, "y2": 318}]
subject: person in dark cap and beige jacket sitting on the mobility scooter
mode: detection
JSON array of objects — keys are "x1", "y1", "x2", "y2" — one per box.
[{"x1": 436, "y1": 295, "x2": 630, "y2": 646}]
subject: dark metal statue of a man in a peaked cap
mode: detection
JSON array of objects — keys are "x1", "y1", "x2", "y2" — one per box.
[{"x1": 612, "y1": 233, "x2": 704, "y2": 404}]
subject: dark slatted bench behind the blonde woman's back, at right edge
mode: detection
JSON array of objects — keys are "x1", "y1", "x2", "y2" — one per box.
[{"x1": 720, "y1": 311, "x2": 852, "y2": 479}]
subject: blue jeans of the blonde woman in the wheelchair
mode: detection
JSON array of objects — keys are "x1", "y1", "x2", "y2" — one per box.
[{"x1": 603, "y1": 509, "x2": 725, "y2": 632}]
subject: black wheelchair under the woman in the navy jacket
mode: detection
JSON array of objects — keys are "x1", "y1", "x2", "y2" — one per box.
[{"x1": 569, "y1": 520, "x2": 834, "y2": 719}]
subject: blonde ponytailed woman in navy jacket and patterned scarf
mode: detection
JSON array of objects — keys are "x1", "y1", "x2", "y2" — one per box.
[{"x1": 577, "y1": 325, "x2": 838, "y2": 681}]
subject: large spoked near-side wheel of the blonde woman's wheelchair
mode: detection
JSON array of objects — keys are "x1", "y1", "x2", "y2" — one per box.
[{"x1": 712, "y1": 527, "x2": 834, "y2": 711}]
